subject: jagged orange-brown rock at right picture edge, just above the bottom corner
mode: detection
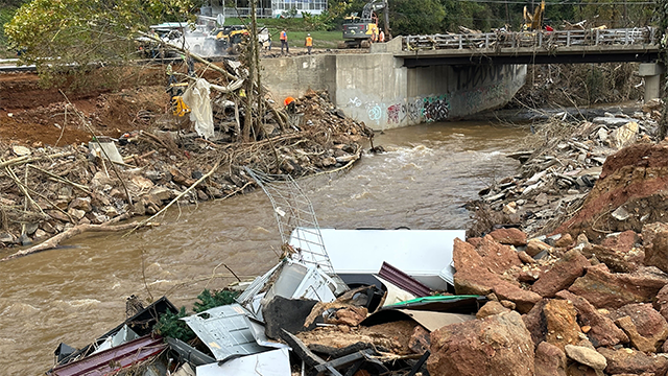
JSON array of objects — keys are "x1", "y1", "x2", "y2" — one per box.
[{"x1": 610, "y1": 304, "x2": 668, "y2": 352}]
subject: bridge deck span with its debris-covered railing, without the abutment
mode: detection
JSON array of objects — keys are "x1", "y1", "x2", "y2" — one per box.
[{"x1": 394, "y1": 27, "x2": 659, "y2": 68}]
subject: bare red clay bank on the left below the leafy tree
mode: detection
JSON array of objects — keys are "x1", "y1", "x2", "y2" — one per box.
[{"x1": 0, "y1": 69, "x2": 169, "y2": 147}]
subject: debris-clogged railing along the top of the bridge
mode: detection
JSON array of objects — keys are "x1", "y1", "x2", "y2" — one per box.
[{"x1": 403, "y1": 27, "x2": 657, "y2": 51}]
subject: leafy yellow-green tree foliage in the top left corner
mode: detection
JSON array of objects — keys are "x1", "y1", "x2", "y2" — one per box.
[{"x1": 4, "y1": 0, "x2": 196, "y2": 69}]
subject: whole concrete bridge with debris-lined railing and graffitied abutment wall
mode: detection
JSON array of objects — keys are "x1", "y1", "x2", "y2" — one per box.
[{"x1": 262, "y1": 29, "x2": 663, "y2": 129}]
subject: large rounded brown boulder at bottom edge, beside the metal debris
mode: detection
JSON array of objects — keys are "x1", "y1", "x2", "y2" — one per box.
[{"x1": 427, "y1": 311, "x2": 534, "y2": 376}]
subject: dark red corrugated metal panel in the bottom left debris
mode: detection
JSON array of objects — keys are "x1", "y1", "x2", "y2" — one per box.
[{"x1": 46, "y1": 335, "x2": 167, "y2": 376}]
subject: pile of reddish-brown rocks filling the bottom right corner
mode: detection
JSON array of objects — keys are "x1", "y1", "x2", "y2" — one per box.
[{"x1": 448, "y1": 223, "x2": 668, "y2": 375}]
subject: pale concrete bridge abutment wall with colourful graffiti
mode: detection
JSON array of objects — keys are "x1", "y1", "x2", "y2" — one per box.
[{"x1": 262, "y1": 47, "x2": 526, "y2": 129}]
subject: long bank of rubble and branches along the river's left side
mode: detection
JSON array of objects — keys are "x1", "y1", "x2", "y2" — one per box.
[{"x1": 0, "y1": 92, "x2": 371, "y2": 254}]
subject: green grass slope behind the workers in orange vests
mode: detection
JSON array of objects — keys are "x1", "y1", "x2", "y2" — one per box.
[{"x1": 225, "y1": 18, "x2": 343, "y2": 49}]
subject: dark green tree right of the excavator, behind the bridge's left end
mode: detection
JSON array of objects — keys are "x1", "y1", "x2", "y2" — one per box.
[{"x1": 390, "y1": 0, "x2": 445, "y2": 35}]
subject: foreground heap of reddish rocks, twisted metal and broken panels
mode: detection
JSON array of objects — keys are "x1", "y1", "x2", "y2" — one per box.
[{"x1": 47, "y1": 216, "x2": 668, "y2": 376}]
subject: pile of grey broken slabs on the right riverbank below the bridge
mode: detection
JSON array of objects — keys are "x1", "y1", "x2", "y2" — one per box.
[{"x1": 469, "y1": 100, "x2": 661, "y2": 236}]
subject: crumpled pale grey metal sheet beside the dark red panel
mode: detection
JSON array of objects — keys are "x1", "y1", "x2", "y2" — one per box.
[{"x1": 181, "y1": 304, "x2": 267, "y2": 362}]
